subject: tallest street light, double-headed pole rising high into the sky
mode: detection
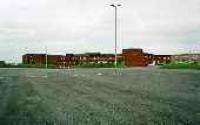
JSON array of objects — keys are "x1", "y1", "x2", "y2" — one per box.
[{"x1": 110, "y1": 4, "x2": 122, "y2": 69}]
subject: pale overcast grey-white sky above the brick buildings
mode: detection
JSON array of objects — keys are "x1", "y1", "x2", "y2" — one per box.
[{"x1": 0, "y1": 0, "x2": 200, "y2": 62}]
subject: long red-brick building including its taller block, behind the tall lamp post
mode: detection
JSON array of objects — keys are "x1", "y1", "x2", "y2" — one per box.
[{"x1": 22, "y1": 48, "x2": 171, "y2": 68}]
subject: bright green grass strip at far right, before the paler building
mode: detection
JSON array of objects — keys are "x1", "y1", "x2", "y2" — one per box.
[{"x1": 161, "y1": 62, "x2": 200, "y2": 70}]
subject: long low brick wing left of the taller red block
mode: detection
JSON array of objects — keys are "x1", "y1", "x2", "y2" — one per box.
[{"x1": 22, "y1": 53, "x2": 123, "y2": 68}]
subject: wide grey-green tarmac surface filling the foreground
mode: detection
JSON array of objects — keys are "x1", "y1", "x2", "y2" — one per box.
[{"x1": 0, "y1": 68, "x2": 200, "y2": 125}]
